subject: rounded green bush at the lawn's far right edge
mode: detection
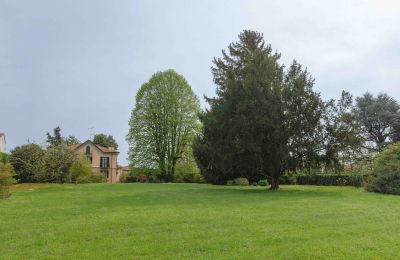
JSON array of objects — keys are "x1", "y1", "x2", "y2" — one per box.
[{"x1": 366, "y1": 143, "x2": 400, "y2": 194}]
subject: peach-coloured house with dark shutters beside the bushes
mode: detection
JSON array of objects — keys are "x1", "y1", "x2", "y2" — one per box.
[{"x1": 71, "y1": 140, "x2": 119, "y2": 183}]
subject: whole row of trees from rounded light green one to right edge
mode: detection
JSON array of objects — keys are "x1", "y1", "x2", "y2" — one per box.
[{"x1": 127, "y1": 31, "x2": 400, "y2": 190}]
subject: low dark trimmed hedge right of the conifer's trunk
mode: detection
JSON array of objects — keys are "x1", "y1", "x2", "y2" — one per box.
[{"x1": 296, "y1": 175, "x2": 365, "y2": 187}]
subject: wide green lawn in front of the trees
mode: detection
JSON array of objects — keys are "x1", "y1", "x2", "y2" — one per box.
[{"x1": 0, "y1": 184, "x2": 400, "y2": 259}]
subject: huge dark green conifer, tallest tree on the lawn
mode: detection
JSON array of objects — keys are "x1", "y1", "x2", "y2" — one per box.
[{"x1": 194, "y1": 31, "x2": 322, "y2": 190}]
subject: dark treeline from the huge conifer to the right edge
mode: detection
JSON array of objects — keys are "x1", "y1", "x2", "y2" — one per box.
[{"x1": 194, "y1": 31, "x2": 400, "y2": 189}]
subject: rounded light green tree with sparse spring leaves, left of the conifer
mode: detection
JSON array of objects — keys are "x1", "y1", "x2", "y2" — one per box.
[{"x1": 127, "y1": 70, "x2": 200, "y2": 181}]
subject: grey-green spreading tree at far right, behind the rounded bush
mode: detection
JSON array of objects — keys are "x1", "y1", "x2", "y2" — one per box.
[{"x1": 355, "y1": 93, "x2": 400, "y2": 152}]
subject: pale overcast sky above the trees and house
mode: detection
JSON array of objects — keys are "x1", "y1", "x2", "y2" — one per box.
[{"x1": 0, "y1": 0, "x2": 400, "y2": 164}]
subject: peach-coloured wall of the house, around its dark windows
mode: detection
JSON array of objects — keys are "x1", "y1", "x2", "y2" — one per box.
[{"x1": 75, "y1": 143, "x2": 118, "y2": 183}]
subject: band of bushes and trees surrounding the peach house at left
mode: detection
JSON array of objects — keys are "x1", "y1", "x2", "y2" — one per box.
[{"x1": 0, "y1": 127, "x2": 118, "y2": 197}]
